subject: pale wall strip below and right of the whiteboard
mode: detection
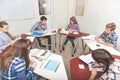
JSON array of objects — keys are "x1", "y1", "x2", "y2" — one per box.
[{"x1": 4, "y1": 0, "x2": 39, "y2": 35}]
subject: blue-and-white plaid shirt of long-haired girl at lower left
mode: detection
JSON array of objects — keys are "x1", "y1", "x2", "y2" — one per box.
[{"x1": 1, "y1": 57, "x2": 34, "y2": 80}]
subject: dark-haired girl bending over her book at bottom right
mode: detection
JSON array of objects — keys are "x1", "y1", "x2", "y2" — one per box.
[{"x1": 89, "y1": 49, "x2": 120, "y2": 80}]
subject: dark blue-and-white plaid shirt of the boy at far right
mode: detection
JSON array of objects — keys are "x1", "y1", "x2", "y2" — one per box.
[{"x1": 100, "y1": 32, "x2": 118, "y2": 47}]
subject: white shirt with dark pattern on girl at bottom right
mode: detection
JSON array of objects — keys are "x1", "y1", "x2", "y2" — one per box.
[{"x1": 97, "y1": 59, "x2": 120, "y2": 80}]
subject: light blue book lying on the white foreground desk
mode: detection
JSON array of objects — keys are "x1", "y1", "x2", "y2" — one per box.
[{"x1": 45, "y1": 60, "x2": 60, "y2": 72}]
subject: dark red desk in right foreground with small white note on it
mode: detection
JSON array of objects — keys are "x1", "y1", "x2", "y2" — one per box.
[{"x1": 70, "y1": 52, "x2": 120, "y2": 80}]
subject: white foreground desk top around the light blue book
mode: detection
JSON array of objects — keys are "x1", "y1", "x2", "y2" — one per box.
[{"x1": 30, "y1": 53, "x2": 68, "y2": 80}]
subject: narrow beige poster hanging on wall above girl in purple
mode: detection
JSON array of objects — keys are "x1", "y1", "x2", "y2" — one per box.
[{"x1": 76, "y1": 0, "x2": 85, "y2": 16}]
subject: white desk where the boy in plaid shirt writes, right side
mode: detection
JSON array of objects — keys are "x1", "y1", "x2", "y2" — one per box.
[{"x1": 82, "y1": 34, "x2": 120, "y2": 56}]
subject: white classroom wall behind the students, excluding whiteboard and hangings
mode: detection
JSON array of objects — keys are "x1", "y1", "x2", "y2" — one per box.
[{"x1": 0, "y1": 0, "x2": 120, "y2": 36}]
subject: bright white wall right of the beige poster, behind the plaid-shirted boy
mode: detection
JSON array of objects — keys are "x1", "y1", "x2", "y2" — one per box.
[{"x1": 81, "y1": 0, "x2": 120, "y2": 34}]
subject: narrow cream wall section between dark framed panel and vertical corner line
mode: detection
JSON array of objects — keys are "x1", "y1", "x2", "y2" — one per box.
[{"x1": 53, "y1": 0, "x2": 68, "y2": 28}]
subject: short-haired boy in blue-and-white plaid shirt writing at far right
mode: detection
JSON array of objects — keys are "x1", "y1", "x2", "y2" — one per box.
[{"x1": 95, "y1": 23, "x2": 118, "y2": 48}]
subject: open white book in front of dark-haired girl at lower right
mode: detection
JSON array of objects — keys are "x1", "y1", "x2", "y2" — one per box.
[{"x1": 78, "y1": 54, "x2": 104, "y2": 72}]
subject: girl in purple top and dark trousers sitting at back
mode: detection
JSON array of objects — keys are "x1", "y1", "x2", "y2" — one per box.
[{"x1": 62, "y1": 16, "x2": 80, "y2": 53}]
